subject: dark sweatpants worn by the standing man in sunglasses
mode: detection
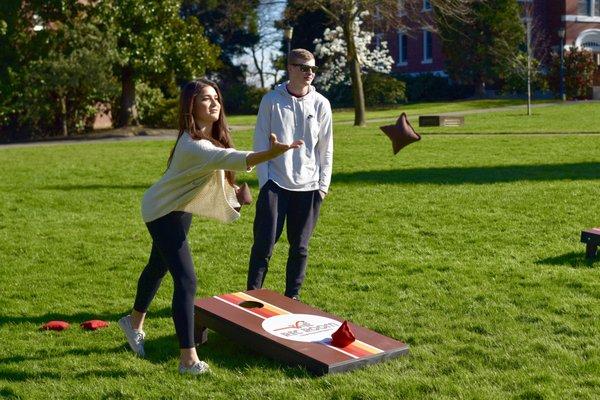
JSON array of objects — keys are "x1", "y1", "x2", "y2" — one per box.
[{"x1": 247, "y1": 180, "x2": 322, "y2": 297}]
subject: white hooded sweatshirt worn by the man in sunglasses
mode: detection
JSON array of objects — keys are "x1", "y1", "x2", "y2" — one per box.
[{"x1": 254, "y1": 82, "x2": 333, "y2": 193}]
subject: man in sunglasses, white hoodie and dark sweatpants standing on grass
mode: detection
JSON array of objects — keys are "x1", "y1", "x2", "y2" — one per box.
[{"x1": 248, "y1": 49, "x2": 333, "y2": 299}]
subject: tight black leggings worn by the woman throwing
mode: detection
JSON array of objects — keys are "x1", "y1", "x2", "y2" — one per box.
[{"x1": 133, "y1": 211, "x2": 196, "y2": 349}]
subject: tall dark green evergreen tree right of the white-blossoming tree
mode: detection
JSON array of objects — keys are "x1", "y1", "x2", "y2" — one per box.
[{"x1": 434, "y1": 0, "x2": 524, "y2": 95}]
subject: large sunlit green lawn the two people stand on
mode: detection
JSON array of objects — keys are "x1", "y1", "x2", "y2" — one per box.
[{"x1": 0, "y1": 108, "x2": 600, "y2": 399}]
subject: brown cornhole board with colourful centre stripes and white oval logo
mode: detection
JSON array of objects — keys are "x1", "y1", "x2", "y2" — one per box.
[{"x1": 195, "y1": 289, "x2": 408, "y2": 375}]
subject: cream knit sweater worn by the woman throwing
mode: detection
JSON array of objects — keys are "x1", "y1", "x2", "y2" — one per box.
[{"x1": 142, "y1": 133, "x2": 250, "y2": 222}]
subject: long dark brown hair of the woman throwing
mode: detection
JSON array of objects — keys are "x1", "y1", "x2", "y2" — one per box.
[{"x1": 167, "y1": 78, "x2": 235, "y2": 186}]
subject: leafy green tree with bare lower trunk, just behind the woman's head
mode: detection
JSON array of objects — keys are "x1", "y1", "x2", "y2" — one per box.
[{"x1": 106, "y1": 0, "x2": 219, "y2": 126}]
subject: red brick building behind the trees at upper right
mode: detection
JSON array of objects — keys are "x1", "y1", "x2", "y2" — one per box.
[{"x1": 383, "y1": 0, "x2": 600, "y2": 97}]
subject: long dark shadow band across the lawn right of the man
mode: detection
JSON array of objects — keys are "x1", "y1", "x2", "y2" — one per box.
[{"x1": 333, "y1": 162, "x2": 600, "y2": 185}]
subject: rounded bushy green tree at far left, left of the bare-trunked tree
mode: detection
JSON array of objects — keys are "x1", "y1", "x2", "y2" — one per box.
[{"x1": 14, "y1": 24, "x2": 117, "y2": 136}]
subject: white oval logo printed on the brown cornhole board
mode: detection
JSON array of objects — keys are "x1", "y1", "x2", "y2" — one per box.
[{"x1": 262, "y1": 314, "x2": 342, "y2": 342}]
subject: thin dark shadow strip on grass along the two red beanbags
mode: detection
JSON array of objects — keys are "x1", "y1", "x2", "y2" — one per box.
[{"x1": 0, "y1": 307, "x2": 171, "y2": 329}]
